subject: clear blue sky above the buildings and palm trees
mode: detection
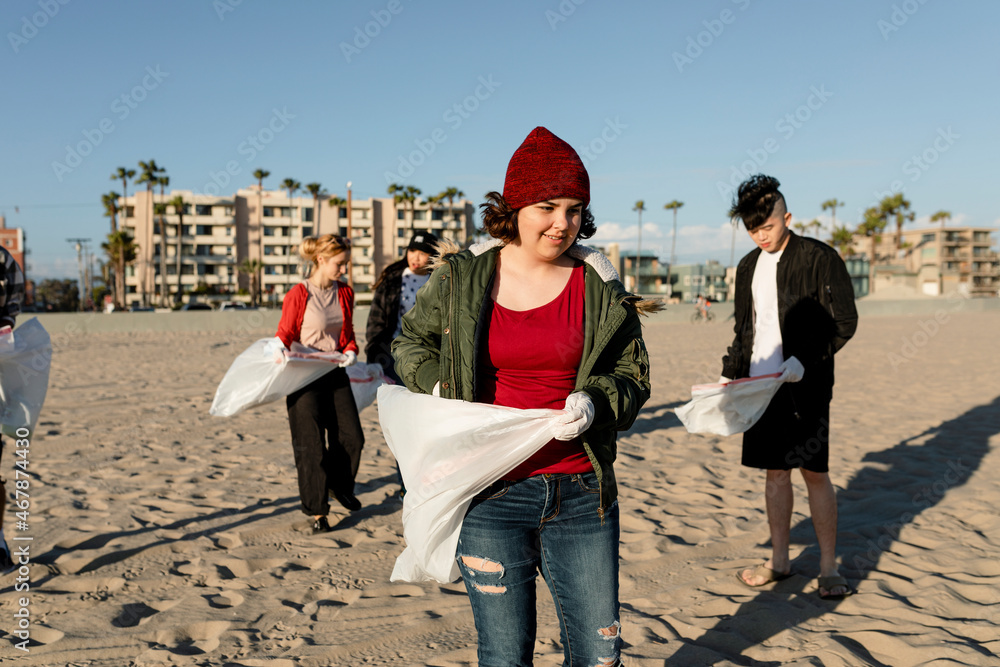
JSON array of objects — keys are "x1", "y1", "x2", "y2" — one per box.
[{"x1": 0, "y1": 0, "x2": 1000, "y2": 279}]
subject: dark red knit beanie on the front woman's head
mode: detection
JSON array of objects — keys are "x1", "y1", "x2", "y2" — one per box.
[{"x1": 503, "y1": 127, "x2": 590, "y2": 209}]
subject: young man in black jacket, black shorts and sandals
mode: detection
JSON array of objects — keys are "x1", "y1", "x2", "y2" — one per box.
[{"x1": 722, "y1": 174, "x2": 858, "y2": 599}]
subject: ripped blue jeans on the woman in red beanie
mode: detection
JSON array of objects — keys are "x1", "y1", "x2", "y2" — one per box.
[{"x1": 456, "y1": 472, "x2": 622, "y2": 667}]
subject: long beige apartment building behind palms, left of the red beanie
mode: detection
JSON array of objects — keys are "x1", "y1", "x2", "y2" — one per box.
[{"x1": 123, "y1": 187, "x2": 475, "y2": 305}]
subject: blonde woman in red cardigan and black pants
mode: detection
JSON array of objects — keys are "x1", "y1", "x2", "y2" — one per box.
[{"x1": 277, "y1": 234, "x2": 365, "y2": 533}]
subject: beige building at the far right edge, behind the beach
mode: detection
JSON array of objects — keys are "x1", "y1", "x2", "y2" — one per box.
[{"x1": 855, "y1": 227, "x2": 1000, "y2": 297}]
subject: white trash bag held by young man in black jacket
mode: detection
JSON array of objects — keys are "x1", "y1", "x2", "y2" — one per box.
[{"x1": 676, "y1": 357, "x2": 805, "y2": 435}]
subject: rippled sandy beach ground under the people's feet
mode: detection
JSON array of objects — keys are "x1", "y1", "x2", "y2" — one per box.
[{"x1": 0, "y1": 305, "x2": 1000, "y2": 667}]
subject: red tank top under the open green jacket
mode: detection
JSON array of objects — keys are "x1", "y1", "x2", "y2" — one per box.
[{"x1": 478, "y1": 263, "x2": 594, "y2": 480}]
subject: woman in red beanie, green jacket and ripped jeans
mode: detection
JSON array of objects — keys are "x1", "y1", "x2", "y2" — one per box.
[{"x1": 392, "y1": 127, "x2": 655, "y2": 665}]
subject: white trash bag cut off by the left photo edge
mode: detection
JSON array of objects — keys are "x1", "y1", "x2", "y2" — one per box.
[{"x1": 0, "y1": 317, "x2": 52, "y2": 437}]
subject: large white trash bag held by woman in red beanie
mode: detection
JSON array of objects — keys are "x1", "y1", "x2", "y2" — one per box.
[{"x1": 378, "y1": 386, "x2": 564, "y2": 583}]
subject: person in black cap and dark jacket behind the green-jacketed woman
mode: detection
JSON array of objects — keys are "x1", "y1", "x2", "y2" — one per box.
[{"x1": 365, "y1": 232, "x2": 438, "y2": 496}]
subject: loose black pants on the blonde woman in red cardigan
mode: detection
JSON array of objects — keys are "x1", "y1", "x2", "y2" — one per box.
[{"x1": 286, "y1": 368, "x2": 365, "y2": 516}]
